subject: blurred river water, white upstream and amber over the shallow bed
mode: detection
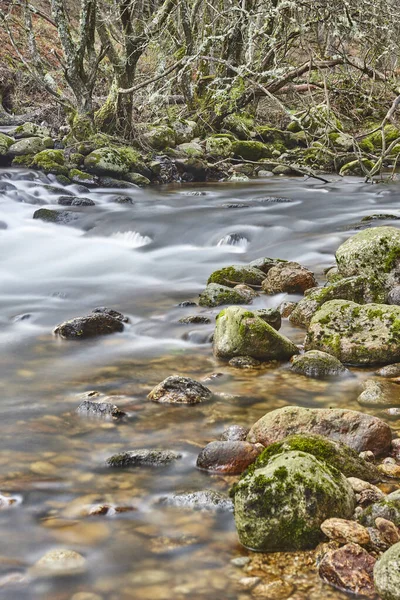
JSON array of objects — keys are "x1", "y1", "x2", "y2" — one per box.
[{"x1": 0, "y1": 157, "x2": 400, "y2": 600}]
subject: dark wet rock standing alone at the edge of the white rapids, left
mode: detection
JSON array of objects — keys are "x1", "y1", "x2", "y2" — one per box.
[{"x1": 54, "y1": 313, "x2": 124, "y2": 340}]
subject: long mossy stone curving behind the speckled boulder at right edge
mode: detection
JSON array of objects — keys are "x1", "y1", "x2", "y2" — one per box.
[{"x1": 289, "y1": 275, "x2": 387, "y2": 327}]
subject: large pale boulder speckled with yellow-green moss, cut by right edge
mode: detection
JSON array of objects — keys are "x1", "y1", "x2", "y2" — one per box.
[{"x1": 305, "y1": 300, "x2": 400, "y2": 366}]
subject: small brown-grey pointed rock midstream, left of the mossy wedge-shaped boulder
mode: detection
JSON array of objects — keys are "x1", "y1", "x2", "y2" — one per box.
[{"x1": 147, "y1": 375, "x2": 212, "y2": 404}]
